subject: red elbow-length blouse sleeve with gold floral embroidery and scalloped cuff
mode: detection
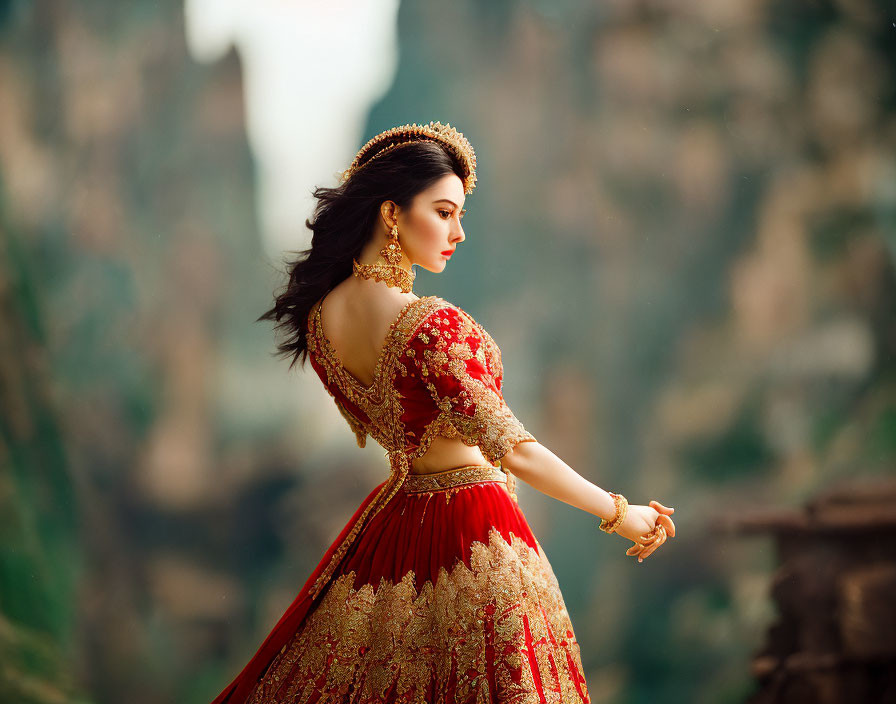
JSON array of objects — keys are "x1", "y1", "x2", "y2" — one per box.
[{"x1": 402, "y1": 305, "x2": 535, "y2": 464}]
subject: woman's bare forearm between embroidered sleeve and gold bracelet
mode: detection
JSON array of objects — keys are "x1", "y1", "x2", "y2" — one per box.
[{"x1": 501, "y1": 441, "x2": 616, "y2": 520}]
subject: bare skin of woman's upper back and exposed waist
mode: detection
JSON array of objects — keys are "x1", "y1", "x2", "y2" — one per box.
[{"x1": 320, "y1": 277, "x2": 489, "y2": 474}]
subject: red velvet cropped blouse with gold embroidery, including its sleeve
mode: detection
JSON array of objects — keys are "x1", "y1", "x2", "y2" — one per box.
[{"x1": 306, "y1": 296, "x2": 535, "y2": 464}]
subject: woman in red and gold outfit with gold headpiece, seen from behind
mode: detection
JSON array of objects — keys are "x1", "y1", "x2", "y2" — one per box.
[{"x1": 213, "y1": 122, "x2": 675, "y2": 704}]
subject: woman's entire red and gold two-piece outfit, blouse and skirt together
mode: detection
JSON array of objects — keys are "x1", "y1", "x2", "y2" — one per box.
[{"x1": 212, "y1": 296, "x2": 590, "y2": 704}]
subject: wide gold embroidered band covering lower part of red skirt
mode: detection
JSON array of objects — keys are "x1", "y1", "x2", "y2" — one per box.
[{"x1": 249, "y1": 529, "x2": 590, "y2": 704}]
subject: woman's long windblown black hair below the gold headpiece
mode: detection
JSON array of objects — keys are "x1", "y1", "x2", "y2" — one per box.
[{"x1": 256, "y1": 141, "x2": 464, "y2": 369}]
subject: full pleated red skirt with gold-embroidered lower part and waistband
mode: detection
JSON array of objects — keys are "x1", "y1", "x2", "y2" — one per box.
[{"x1": 213, "y1": 466, "x2": 590, "y2": 704}]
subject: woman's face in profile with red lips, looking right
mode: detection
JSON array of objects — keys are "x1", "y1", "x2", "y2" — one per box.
[{"x1": 395, "y1": 174, "x2": 466, "y2": 273}]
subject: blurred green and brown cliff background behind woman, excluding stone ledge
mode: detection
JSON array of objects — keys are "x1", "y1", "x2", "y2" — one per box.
[{"x1": 0, "y1": 0, "x2": 896, "y2": 704}]
